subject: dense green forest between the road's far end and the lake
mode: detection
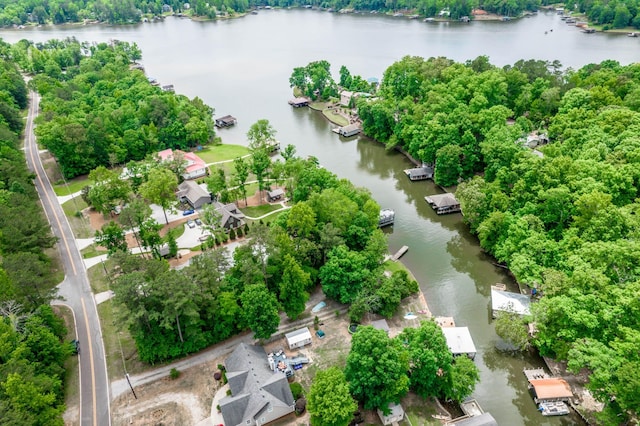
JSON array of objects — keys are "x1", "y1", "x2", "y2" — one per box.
[{"x1": 22, "y1": 40, "x2": 214, "y2": 178}]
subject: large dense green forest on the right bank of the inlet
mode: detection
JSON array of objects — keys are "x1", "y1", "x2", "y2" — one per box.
[{"x1": 348, "y1": 57, "x2": 640, "y2": 423}]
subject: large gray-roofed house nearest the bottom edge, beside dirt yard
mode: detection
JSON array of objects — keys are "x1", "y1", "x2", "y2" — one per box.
[{"x1": 219, "y1": 343, "x2": 295, "y2": 426}]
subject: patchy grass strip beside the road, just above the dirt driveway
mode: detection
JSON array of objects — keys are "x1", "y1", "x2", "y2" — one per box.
[{"x1": 98, "y1": 300, "x2": 153, "y2": 380}]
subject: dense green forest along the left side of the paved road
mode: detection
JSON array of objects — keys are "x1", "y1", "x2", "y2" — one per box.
[{"x1": 0, "y1": 49, "x2": 71, "y2": 425}]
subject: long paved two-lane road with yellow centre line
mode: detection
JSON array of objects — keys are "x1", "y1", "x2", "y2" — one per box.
[{"x1": 25, "y1": 92, "x2": 111, "y2": 426}]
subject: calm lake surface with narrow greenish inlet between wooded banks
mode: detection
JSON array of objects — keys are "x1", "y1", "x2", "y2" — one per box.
[{"x1": 0, "y1": 9, "x2": 640, "y2": 426}]
